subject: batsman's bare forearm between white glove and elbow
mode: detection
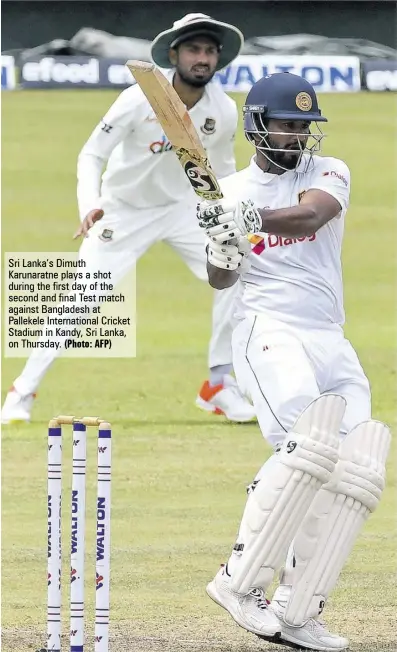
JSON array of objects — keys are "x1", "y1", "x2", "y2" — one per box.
[{"x1": 259, "y1": 204, "x2": 322, "y2": 238}]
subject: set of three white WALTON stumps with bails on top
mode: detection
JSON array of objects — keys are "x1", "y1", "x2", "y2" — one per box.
[{"x1": 47, "y1": 416, "x2": 112, "y2": 652}]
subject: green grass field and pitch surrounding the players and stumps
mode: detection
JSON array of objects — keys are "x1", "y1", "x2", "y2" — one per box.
[{"x1": 2, "y1": 90, "x2": 397, "y2": 652}]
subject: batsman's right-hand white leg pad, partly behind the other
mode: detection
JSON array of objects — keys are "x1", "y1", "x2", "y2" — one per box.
[{"x1": 273, "y1": 421, "x2": 390, "y2": 627}]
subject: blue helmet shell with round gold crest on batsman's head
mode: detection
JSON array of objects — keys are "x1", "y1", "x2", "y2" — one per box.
[{"x1": 243, "y1": 72, "x2": 328, "y2": 126}]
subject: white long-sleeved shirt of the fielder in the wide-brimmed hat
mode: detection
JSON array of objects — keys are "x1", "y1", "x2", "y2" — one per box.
[{"x1": 77, "y1": 71, "x2": 238, "y2": 219}]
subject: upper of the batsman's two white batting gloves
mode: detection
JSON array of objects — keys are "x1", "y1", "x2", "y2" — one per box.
[{"x1": 197, "y1": 199, "x2": 262, "y2": 242}]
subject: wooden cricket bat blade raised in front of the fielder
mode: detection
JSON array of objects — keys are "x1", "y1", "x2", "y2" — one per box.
[{"x1": 126, "y1": 61, "x2": 223, "y2": 201}]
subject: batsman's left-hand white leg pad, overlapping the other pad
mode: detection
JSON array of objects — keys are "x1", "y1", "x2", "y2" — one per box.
[{"x1": 231, "y1": 394, "x2": 346, "y2": 594}]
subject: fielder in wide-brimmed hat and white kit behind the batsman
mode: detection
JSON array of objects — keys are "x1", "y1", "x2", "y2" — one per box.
[{"x1": 2, "y1": 14, "x2": 254, "y2": 423}]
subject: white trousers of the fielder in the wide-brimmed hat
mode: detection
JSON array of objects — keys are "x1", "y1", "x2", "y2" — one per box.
[{"x1": 14, "y1": 197, "x2": 238, "y2": 395}]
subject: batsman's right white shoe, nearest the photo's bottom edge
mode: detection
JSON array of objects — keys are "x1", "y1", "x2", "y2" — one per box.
[{"x1": 270, "y1": 600, "x2": 349, "y2": 652}]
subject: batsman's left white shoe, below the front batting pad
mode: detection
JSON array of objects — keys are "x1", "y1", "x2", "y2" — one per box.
[{"x1": 207, "y1": 566, "x2": 281, "y2": 637}]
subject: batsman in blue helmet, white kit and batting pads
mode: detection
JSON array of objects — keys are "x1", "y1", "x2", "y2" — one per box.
[{"x1": 198, "y1": 73, "x2": 390, "y2": 652}]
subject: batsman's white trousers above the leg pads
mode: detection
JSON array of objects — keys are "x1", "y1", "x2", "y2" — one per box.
[{"x1": 232, "y1": 314, "x2": 371, "y2": 446}]
